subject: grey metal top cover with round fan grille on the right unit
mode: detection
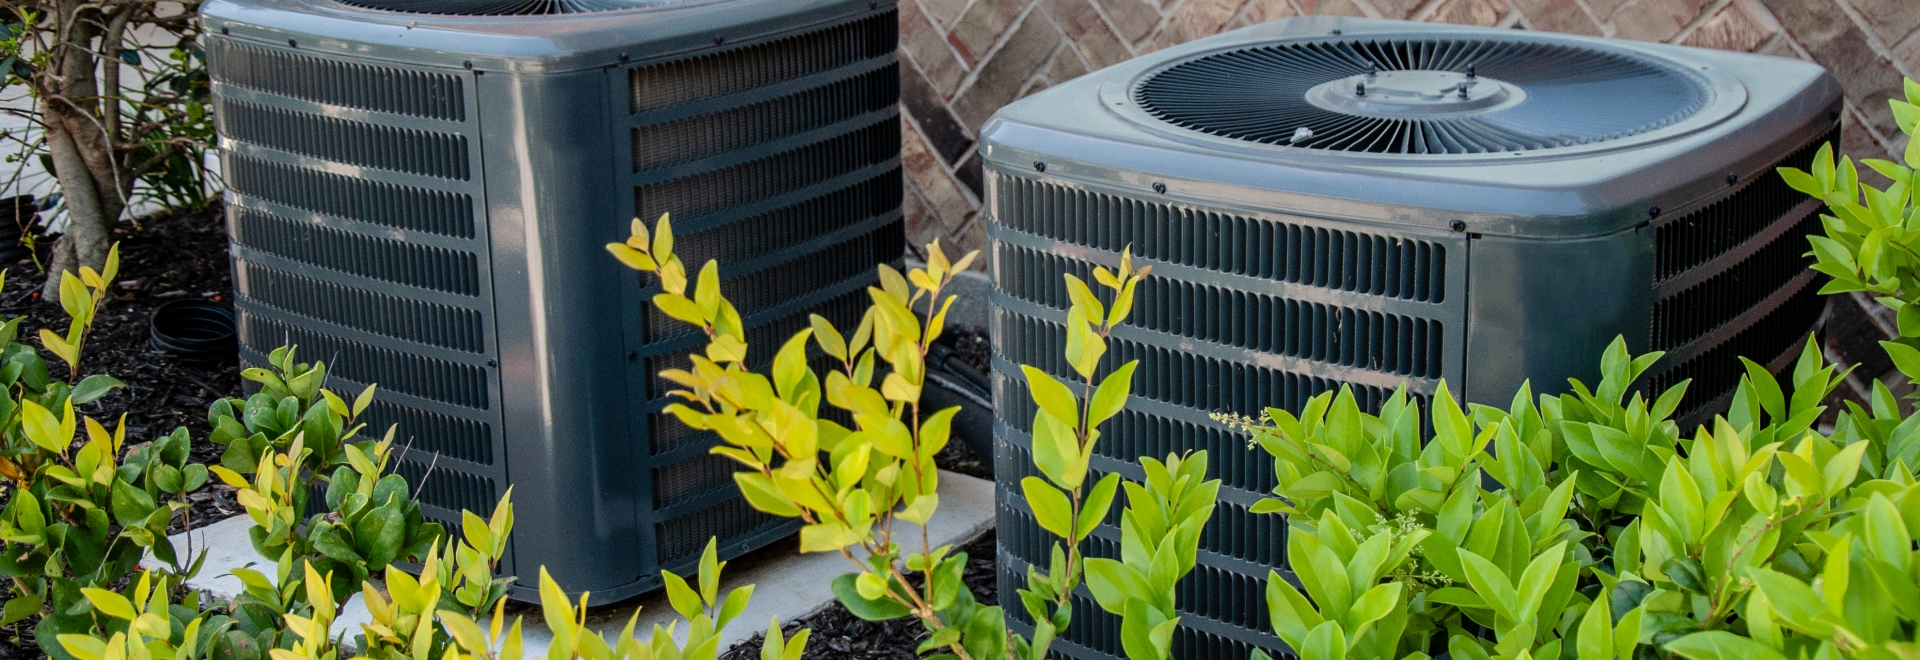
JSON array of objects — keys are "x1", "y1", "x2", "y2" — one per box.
[{"x1": 981, "y1": 17, "x2": 1839, "y2": 236}]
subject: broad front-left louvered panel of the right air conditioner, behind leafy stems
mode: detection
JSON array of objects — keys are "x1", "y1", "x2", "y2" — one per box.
[{"x1": 989, "y1": 173, "x2": 1465, "y2": 658}]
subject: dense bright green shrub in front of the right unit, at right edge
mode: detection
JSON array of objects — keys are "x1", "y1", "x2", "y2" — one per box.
[{"x1": 1223, "y1": 74, "x2": 1920, "y2": 660}]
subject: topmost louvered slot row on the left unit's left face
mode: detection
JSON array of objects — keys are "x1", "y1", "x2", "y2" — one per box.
[{"x1": 207, "y1": 38, "x2": 467, "y2": 121}]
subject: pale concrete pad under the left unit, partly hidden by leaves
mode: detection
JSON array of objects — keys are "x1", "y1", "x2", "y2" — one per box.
[{"x1": 146, "y1": 472, "x2": 995, "y2": 658}]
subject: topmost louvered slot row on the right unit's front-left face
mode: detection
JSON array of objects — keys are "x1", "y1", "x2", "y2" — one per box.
[{"x1": 995, "y1": 175, "x2": 1446, "y2": 303}]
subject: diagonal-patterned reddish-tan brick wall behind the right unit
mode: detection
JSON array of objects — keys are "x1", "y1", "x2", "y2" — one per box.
[{"x1": 900, "y1": 0, "x2": 1920, "y2": 265}]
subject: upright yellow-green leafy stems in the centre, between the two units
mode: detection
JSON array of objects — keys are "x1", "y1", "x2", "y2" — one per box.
[{"x1": 607, "y1": 215, "x2": 1217, "y2": 660}]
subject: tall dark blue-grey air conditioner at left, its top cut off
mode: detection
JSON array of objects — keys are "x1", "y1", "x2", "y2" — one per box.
[{"x1": 204, "y1": 0, "x2": 904, "y2": 602}]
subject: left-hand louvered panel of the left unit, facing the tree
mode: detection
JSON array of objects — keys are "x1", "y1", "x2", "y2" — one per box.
[{"x1": 207, "y1": 35, "x2": 511, "y2": 544}]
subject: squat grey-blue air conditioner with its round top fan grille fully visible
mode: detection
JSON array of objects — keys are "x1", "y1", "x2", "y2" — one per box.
[{"x1": 981, "y1": 19, "x2": 1841, "y2": 658}]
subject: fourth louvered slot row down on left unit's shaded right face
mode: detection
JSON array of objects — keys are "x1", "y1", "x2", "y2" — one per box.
[{"x1": 647, "y1": 169, "x2": 904, "y2": 274}]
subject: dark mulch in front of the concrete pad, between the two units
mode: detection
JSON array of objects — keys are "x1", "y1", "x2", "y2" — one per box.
[{"x1": 720, "y1": 531, "x2": 1000, "y2": 660}]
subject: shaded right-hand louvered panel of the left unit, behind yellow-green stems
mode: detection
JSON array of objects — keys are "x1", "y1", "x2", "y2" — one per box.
[{"x1": 622, "y1": 12, "x2": 906, "y2": 570}]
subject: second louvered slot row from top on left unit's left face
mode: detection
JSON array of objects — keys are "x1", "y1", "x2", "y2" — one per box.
[{"x1": 219, "y1": 100, "x2": 467, "y2": 180}]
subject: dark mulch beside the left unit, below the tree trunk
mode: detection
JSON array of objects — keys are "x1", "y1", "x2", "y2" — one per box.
[{"x1": 0, "y1": 205, "x2": 240, "y2": 660}]
